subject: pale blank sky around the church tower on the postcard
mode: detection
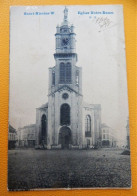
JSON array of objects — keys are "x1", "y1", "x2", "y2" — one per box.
[{"x1": 9, "y1": 5, "x2": 128, "y2": 144}]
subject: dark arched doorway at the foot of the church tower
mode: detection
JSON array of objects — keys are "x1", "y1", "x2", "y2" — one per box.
[{"x1": 59, "y1": 126, "x2": 71, "y2": 149}]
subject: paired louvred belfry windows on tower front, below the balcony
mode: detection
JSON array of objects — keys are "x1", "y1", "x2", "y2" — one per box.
[{"x1": 60, "y1": 63, "x2": 71, "y2": 84}]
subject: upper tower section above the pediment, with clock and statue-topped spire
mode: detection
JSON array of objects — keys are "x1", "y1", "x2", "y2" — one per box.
[{"x1": 49, "y1": 7, "x2": 82, "y2": 94}]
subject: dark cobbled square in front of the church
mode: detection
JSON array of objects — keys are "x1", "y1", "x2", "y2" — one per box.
[{"x1": 8, "y1": 149, "x2": 131, "y2": 190}]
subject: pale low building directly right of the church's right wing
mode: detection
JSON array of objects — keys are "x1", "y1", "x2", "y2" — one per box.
[{"x1": 101, "y1": 124, "x2": 117, "y2": 147}]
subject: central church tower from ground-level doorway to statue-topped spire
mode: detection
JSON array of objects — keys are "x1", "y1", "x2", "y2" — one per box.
[{"x1": 47, "y1": 7, "x2": 83, "y2": 148}]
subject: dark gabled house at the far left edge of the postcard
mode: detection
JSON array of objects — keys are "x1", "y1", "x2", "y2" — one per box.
[{"x1": 8, "y1": 125, "x2": 17, "y2": 149}]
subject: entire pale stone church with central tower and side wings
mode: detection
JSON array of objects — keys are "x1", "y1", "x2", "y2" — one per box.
[{"x1": 35, "y1": 8, "x2": 101, "y2": 149}]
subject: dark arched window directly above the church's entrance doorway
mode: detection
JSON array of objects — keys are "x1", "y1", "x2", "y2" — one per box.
[{"x1": 60, "y1": 103, "x2": 70, "y2": 125}]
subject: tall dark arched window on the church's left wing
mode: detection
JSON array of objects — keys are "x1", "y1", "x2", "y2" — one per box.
[{"x1": 41, "y1": 114, "x2": 47, "y2": 143}]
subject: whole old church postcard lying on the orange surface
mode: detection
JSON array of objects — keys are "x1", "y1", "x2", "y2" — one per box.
[{"x1": 8, "y1": 5, "x2": 131, "y2": 191}]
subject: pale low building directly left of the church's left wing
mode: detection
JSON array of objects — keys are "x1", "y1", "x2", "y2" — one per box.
[{"x1": 18, "y1": 124, "x2": 36, "y2": 147}]
